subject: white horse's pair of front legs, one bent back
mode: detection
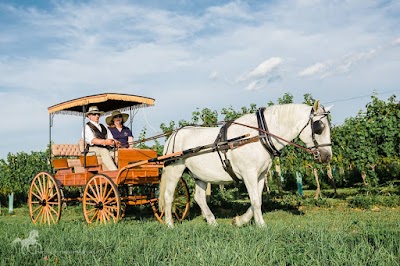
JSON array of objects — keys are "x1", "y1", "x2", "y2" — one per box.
[{"x1": 232, "y1": 174, "x2": 265, "y2": 226}]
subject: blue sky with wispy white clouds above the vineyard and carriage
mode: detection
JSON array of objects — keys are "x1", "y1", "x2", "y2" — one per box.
[{"x1": 0, "y1": 0, "x2": 400, "y2": 158}]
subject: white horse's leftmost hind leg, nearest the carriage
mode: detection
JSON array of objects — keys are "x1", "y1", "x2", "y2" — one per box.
[{"x1": 162, "y1": 164, "x2": 186, "y2": 227}]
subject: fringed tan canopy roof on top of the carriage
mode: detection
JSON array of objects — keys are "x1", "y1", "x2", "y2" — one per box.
[{"x1": 47, "y1": 93, "x2": 154, "y2": 115}]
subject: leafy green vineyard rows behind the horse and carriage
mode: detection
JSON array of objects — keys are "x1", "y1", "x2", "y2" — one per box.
[{"x1": 0, "y1": 93, "x2": 400, "y2": 202}]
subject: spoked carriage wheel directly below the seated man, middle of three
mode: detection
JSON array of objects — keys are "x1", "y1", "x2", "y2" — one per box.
[{"x1": 82, "y1": 174, "x2": 121, "y2": 224}]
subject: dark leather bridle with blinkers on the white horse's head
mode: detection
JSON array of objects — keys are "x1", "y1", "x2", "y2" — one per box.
[{"x1": 299, "y1": 107, "x2": 332, "y2": 160}]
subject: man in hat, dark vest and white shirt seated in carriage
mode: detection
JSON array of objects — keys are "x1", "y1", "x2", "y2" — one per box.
[{"x1": 82, "y1": 106, "x2": 120, "y2": 170}]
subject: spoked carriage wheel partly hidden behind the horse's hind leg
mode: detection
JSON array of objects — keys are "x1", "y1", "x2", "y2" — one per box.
[{"x1": 151, "y1": 177, "x2": 190, "y2": 223}]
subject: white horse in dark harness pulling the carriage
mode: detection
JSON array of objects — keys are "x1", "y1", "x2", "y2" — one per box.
[{"x1": 159, "y1": 101, "x2": 332, "y2": 227}]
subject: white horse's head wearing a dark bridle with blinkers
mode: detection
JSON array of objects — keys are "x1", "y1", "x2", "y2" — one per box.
[{"x1": 299, "y1": 101, "x2": 332, "y2": 163}]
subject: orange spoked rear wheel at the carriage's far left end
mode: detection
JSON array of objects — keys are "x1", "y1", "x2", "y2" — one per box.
[{"x1": 28, "y1": 172, "x2": 62, "y2": 224}]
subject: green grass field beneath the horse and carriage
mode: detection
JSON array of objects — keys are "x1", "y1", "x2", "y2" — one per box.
[{"x1": 0, "y1": 194, "x2": 400, "y2": 265}]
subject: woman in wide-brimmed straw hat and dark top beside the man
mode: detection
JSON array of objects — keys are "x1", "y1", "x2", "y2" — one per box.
[{"x1": 106, "y1": 111, "x2": 133, "y2": 148}]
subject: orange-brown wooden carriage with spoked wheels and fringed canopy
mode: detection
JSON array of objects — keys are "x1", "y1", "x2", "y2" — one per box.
[{"x1": 28, "y1": 93, "x2": 190, "y2": 224}]
